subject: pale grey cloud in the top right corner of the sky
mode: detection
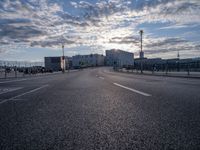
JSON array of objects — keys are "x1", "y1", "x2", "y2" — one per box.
[{"x1": 139, "y1": 0, "x2": 200, "y2": 25}]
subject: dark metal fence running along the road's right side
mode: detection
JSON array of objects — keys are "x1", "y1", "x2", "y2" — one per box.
[{"x1": 114, "y1": 61, "x2": 200, "y2": 76}]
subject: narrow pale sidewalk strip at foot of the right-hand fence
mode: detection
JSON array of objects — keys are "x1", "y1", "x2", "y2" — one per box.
[{"x1": 115, "y1": 69, "x2": 200, "y2": 79}]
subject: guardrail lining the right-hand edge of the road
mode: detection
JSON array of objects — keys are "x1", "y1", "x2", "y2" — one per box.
[{"x1": 114, "y1": 63, "x2": 200, "y2": 78}]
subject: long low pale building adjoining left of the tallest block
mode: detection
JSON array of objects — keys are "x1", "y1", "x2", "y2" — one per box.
[{"x1": 72, "y1": 54, "x2": 105, "y2": 68}]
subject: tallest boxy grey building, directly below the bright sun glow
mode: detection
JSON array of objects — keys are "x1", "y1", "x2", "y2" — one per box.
[{"x1": 106, "y1": 49, "x2": 134, "y2": 67}]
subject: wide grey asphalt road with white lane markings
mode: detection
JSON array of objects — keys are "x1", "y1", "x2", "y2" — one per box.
[{"x1": 0, "y1": 68, "x2": 200, "y2": 150}]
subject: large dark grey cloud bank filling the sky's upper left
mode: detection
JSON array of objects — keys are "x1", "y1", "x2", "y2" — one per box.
[{"x1": 0, "y1": 0, "x2": 87, "y2": 47}]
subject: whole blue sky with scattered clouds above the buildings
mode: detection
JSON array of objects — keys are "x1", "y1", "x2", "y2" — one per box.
[{"x1": 0, "y1": 0, "x2": 200, "y2": 61}]
